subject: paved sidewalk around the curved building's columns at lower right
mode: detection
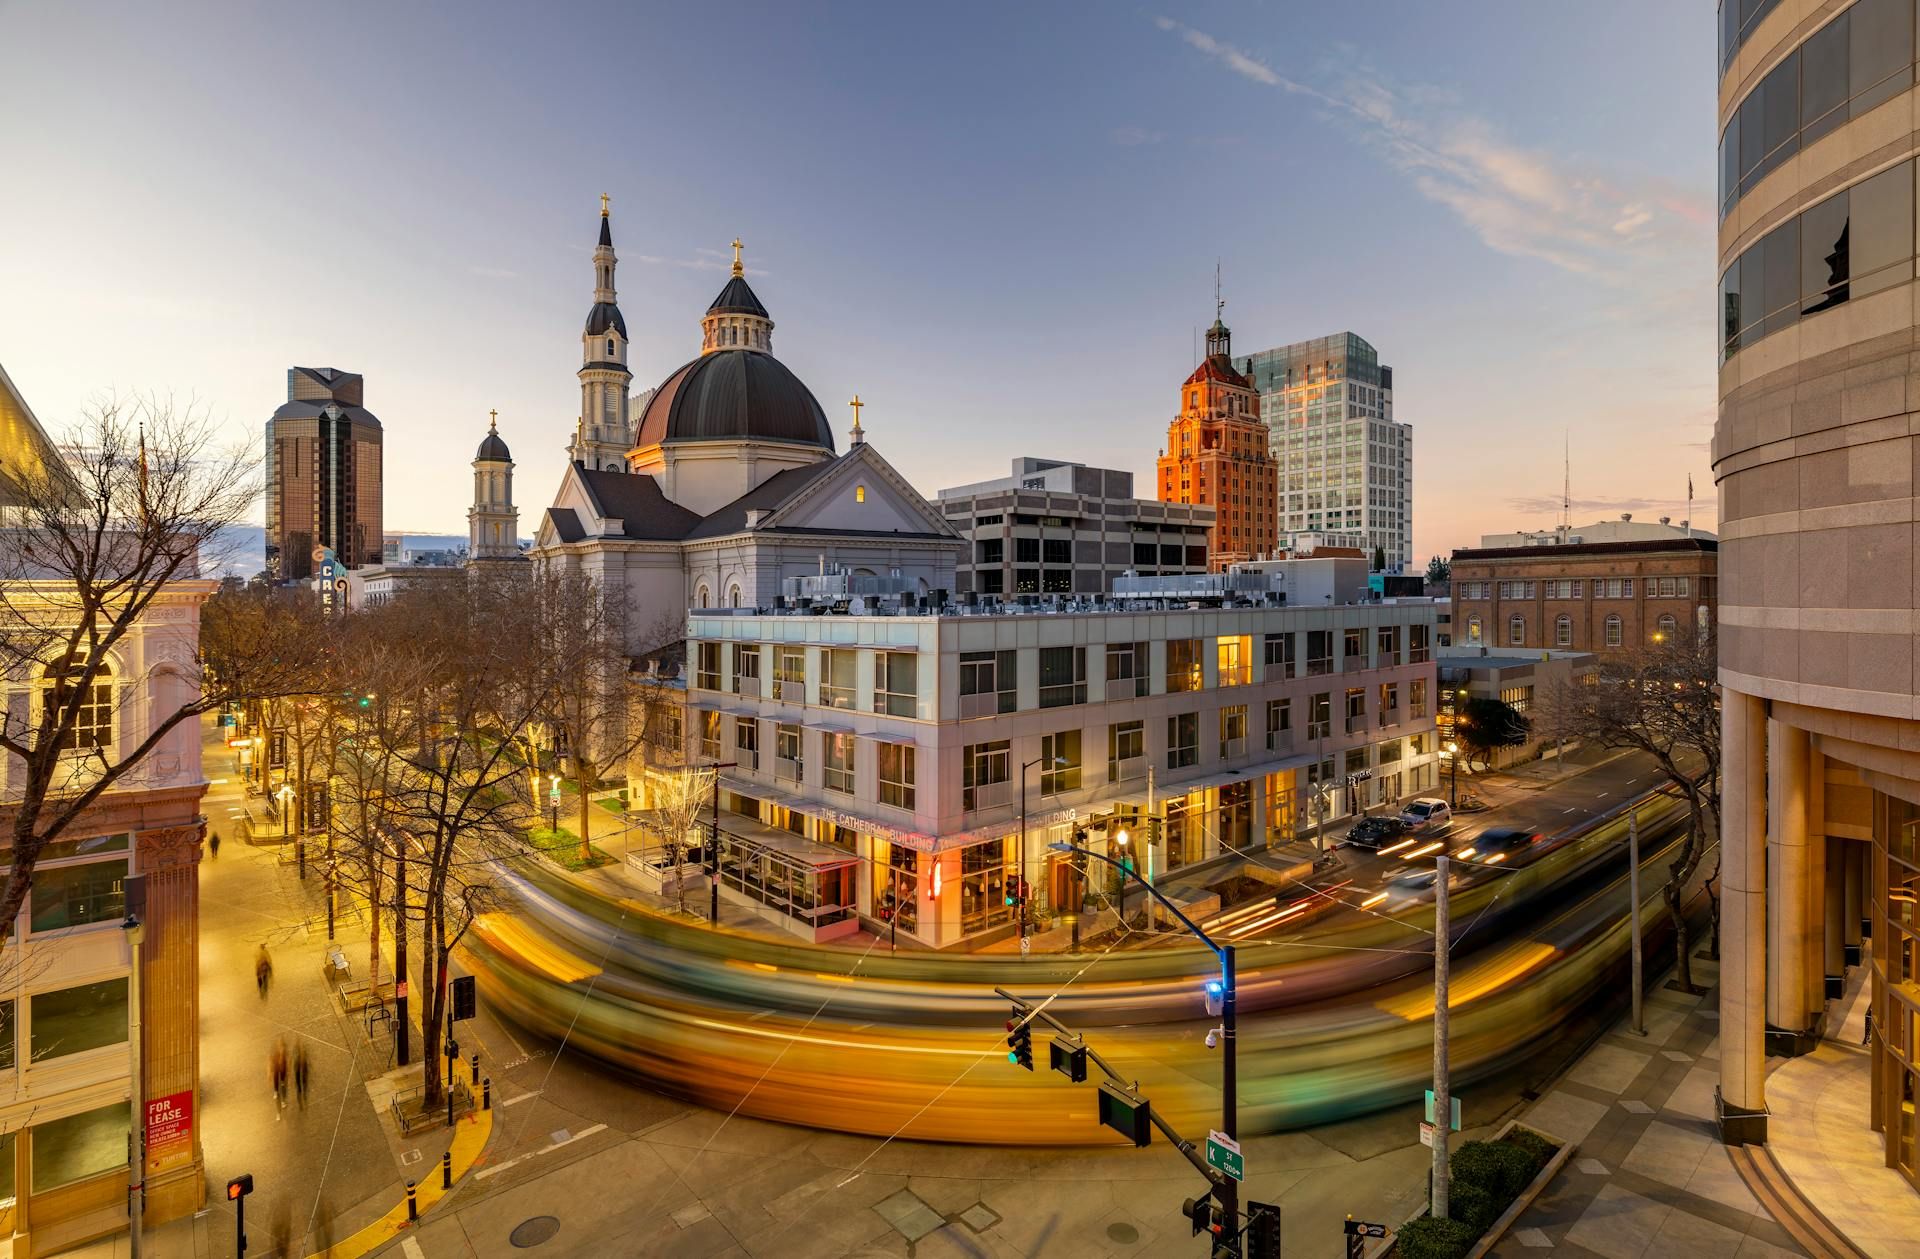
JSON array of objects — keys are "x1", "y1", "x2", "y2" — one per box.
[{"x1": 1490, "y1": 960, "x2": 1920, "y2": 1259}]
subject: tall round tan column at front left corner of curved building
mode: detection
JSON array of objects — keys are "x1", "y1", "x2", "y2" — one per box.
[{"x1": 1715, "y1": 691, "x2": 1766, "y2": 1146}]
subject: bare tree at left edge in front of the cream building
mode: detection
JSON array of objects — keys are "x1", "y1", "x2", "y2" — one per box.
[{"x1": 0, "y1": 401, "x2": 315, "y2": 944}]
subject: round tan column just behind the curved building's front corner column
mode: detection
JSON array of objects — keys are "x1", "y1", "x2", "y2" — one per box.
[{"x1": 1766, "y1": 720, "x2": 1816, "y2": 1057}]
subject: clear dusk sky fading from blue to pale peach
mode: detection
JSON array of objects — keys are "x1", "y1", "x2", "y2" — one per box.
[{"x1": 0, "y1": 0, "x2": 1715, "y2": 557}]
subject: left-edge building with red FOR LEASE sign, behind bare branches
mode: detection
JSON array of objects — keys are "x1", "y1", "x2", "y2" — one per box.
[{"x1": 0, "y1": 358, "x2": 217, "y2": 1257}]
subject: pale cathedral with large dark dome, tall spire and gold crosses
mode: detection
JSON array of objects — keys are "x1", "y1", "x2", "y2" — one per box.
[{"x1": 529, "y1": 198, "x2": 966, "y2": 656}]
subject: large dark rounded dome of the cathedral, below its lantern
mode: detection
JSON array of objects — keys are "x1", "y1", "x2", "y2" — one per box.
[{"x1": 636, "y1": 349, "x2": 833, "y2": 451}]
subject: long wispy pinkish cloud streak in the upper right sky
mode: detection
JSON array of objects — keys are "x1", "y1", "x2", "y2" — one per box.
[{"x1": 1154, "y1": 17, "x2": 1713, "y2": 286}]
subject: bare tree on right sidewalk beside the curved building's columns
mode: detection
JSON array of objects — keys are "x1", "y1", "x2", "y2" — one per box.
[{"x1": 1544, "y1": 633, "x2": 1720, "y2": 990}]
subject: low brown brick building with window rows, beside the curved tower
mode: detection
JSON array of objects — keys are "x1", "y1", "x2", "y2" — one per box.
[{"x1": 1452, "y1": 537, "x2": 1720, "y2": 654}]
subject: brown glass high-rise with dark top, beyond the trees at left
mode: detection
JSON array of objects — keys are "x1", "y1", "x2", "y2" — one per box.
[{"x1": 267, "y1": 367, "x2": 386, "y2": 582}]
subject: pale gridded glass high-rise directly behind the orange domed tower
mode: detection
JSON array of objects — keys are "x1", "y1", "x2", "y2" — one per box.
[{"x1": 1246, "y1": 332, "x2": 1413, "y2": 572}]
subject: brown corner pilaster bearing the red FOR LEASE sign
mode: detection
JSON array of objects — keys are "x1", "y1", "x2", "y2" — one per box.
[{"x1": 136, "y1": 823, "x2": 205, "y2": 1224}]
